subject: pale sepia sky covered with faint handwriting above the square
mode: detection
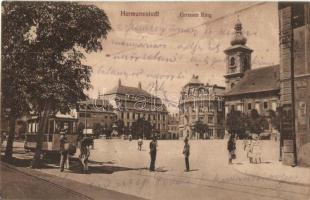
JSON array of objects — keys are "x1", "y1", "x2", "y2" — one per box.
[{"x1": 84, "y1": 2, "x2": 279, "y2": 112}]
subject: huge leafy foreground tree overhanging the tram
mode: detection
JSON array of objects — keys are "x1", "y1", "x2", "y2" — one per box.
[{"x1": 1, "y1": 2, "x2": 111, "y2": 168}]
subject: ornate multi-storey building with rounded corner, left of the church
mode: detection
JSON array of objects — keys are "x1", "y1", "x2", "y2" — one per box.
[{"x1": 179, "y1": 75, "x2": 225, "y2": 139}]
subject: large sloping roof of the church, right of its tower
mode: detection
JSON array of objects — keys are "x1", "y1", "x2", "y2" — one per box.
[{"x1": 225, "y1": 65, "x2": 280, "y2": 96}]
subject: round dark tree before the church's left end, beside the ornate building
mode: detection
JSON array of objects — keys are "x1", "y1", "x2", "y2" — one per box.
[{"x1": 225, "y1": 110, "x2": 247, "y2": 138}]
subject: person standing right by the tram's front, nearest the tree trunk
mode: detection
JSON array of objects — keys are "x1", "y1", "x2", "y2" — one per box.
[{"x1": 59, "y1": 130, "x2": 69, "y2": 172}]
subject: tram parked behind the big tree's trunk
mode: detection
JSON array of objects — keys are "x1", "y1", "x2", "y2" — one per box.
[{"x1": 24, "y1": 113, "x2": 78, "y2": 154}]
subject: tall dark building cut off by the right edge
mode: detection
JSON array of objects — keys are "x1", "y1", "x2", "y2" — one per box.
[{"x1": 278, "y1": 2, "x2": 310, "y2": 167}]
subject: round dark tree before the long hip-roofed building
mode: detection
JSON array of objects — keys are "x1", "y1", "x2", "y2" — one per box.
[{"x1": 131, "y1": 118, "x2": 153, "y2": 139}]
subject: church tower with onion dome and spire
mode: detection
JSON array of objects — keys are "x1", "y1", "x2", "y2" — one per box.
[{"x1": 224, "y1": 18, "x2": 253, "y2": 91}]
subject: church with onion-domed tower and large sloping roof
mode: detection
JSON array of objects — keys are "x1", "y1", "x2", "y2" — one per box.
[{"x1": 224, "y1": 19, "x2": 280, "y2": 129}]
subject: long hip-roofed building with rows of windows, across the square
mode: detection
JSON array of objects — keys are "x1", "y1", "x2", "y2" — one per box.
[{"x1": 103, "y1": 80, "x2": 168, "y2": 137}]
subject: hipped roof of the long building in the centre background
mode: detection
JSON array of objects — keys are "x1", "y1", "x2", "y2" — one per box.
[{"x1": 104, "y1": 85, "x2": 153, "y2": 97}]
